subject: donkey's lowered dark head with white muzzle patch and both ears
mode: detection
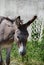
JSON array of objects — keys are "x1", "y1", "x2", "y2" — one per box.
[{"x1": 14, "y1": 16, "x2": 37, "y2": 56}]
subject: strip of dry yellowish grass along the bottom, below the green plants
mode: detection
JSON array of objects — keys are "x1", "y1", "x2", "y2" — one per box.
[{"x1": 10, "y1": 59, "x2": 44, "y2": 65}]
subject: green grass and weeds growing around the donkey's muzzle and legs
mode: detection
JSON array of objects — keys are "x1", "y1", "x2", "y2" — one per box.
[{"x1": 2, "y1": 41, "x2": 44, "y2": 65}]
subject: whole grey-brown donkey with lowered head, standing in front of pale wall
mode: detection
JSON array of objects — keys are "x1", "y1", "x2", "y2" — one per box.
[{"x1": 0, "y1": 15, "x2": 37, "y2": 65}]
